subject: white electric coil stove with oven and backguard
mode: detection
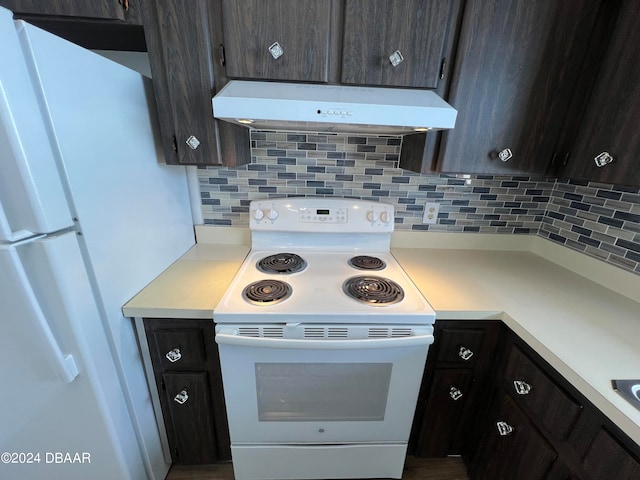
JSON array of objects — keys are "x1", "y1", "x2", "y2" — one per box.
[{"x1": 214, "y1": 198, "x2": 435, "y2": 480}]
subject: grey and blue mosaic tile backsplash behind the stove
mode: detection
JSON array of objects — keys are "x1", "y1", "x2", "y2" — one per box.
[{"x1": 198, "y1": 131, "x2": 640, "y2": 274}]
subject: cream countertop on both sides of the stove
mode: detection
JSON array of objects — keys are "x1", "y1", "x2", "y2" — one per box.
[{"x1": 123, "y1": 227, "x2": 640, "y2": 444}]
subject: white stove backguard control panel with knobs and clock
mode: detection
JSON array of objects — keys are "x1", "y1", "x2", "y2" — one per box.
[{"x1": 249, "y1": 197, "x2": 394, "y2": 233}]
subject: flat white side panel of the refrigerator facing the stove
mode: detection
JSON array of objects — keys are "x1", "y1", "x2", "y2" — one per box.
[{"x1": 19, "y1": 16, "x2": 195, "y2": 478}]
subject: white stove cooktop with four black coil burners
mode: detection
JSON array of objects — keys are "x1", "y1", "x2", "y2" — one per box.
[{"x1": 214, "y1": 251, "x2": 435, "y2": 324}]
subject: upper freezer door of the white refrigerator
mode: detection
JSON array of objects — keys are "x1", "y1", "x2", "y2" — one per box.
[{"x1": 0, "y1": 8, "x2": 73, "y2": 242}]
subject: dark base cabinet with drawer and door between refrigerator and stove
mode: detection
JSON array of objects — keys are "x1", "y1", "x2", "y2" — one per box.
[{"x1": 144, "y1": 318, "x2": 231, "y2": 464}]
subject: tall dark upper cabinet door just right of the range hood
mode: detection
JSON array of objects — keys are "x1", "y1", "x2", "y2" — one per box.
[{"x1": 437, "y1": 0, "x2": 599, "y2": 174}]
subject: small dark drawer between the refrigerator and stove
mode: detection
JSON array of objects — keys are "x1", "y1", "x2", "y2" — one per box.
[{"x1": 149, "y1": 328, "x2": 206, "y2": 370}]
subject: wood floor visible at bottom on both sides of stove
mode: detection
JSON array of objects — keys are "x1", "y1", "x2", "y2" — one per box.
[{"x1": 166, "y1": 456, "x2": 469, "y2": 480}]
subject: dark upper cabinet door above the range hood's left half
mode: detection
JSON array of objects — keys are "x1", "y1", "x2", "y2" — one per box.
[{"x1": 222, "y1": 0, "x2": 333, "y2": 82}]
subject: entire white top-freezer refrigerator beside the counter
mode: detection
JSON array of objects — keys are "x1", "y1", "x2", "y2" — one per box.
[{"x1": 0, "y1": 8, "x2": 194, "y2": 480}]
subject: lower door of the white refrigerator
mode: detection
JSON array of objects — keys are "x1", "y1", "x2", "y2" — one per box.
[{"x1": 0, "y1": 232, "x2": 147, "y2": 480}]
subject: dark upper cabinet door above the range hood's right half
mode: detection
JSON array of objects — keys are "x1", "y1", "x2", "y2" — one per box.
[{"x1": 342, "y1": 0, "x2": 460, "y2": 88}]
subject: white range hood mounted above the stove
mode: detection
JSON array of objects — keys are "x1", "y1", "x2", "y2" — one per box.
[{"x1": 213, "y1": 80, "x2": 457, "y2": 135}]
